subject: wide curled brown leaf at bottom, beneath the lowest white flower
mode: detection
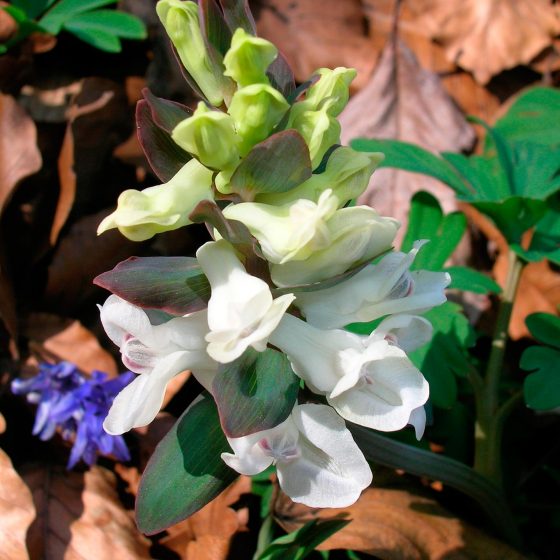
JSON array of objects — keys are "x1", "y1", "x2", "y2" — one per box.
[{"x1": 273, "y1": 488, "x2": 524, "y2": 560}]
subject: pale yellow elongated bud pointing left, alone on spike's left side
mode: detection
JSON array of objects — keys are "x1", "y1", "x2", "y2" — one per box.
[{"x1": 97, "y1": 159, "x2": 212, "y2": 241}]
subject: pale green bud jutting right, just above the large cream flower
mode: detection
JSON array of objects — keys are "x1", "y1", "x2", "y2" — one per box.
[{"x1": 256, "y1": 146, "x2": 383, "y2": 208}]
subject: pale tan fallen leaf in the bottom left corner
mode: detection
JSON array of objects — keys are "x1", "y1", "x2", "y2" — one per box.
[{"x1": 0, "y1": 449, "x2": 35, "y2": 560}]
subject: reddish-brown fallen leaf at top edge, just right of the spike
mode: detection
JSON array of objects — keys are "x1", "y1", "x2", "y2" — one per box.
[{"x1": 254, "y1": 0, "x2": 375, "y2": 89}]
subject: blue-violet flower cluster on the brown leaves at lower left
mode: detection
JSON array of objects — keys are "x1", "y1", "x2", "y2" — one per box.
[{"x1": 12, "y1": 362, "x2": 133, "y2": 469}]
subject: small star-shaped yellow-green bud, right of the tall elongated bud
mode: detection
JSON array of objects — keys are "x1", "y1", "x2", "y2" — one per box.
[{"x1": 224, "y1": 28, "x2": 278, "y2": 87}]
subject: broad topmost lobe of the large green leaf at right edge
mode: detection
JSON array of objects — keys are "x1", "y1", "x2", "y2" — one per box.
[{"x1": 495, "y1": 87, "x2": 560, "y2": 145}]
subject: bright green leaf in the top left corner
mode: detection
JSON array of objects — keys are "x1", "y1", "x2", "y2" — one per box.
[{"x1": 0, "y1": 0, "x2": 147, "y2": 53}]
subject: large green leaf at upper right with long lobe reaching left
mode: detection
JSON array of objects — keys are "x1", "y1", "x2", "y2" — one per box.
[{"x1": 352, "y1": 88, "x2": 560, "y2": 249}]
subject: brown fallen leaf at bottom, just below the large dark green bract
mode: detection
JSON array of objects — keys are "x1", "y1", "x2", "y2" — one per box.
[{"x1": 160, "y1": 476, "x2": 251, "y2": 560}]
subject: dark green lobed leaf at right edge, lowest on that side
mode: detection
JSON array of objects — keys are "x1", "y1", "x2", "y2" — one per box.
[{"x1": 520, "y1": 313, "x2": 560, "y2": 410}]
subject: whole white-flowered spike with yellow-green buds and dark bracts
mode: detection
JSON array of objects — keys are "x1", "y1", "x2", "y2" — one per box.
[{"x1": 94, "y1": 0, "x2": 449, "y2": 532}]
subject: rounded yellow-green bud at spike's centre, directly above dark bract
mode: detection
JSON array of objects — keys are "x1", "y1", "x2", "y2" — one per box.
[{"x1": 228, "y1": 84, "x2": 290, "y2": 156}]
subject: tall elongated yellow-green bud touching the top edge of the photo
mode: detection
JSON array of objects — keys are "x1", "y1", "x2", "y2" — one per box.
[{"x1": 156, "y1": 0, "x2": 233, "y2": 107}]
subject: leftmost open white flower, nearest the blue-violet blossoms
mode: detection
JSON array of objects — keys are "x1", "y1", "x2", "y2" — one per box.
[{"x1": 100, "y1": 295, "x2": 218, "y2": 434}]
